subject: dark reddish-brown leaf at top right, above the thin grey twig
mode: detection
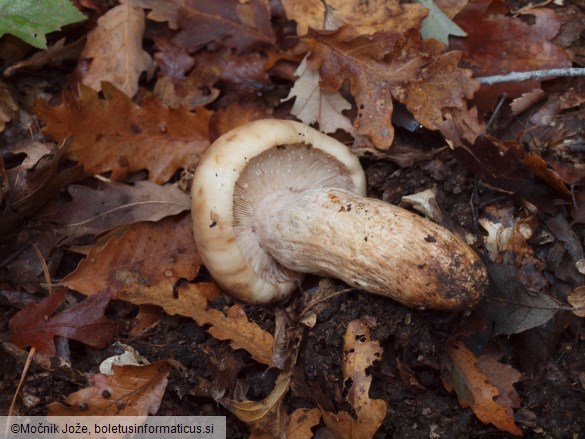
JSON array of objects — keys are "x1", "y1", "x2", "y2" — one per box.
[{"x1": 451, "y1": 0, "x2": 571, "y2": 76}]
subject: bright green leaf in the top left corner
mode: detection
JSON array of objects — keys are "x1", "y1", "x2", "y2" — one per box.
[{"x1": 0, "y1": 0, "x2": 86, "y2": 49}]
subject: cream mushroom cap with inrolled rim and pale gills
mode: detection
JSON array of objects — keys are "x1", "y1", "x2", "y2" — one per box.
[{"x1": 191, "y1": 119, "x2": 366, "y2": 303}]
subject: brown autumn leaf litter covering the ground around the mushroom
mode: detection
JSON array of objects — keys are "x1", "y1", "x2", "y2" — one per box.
[{"x1": 0, "y1": 0, "x2": 585, "y2": 438}]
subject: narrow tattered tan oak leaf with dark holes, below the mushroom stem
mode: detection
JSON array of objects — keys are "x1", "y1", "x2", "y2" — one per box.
[{"x1": 323, "y1": 320, "x2": 386, "y2": 439}]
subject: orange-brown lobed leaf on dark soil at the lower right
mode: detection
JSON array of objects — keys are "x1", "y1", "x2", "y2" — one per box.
[{"x1": 442, "y1": 342, "x2": 522, "y2": 436}]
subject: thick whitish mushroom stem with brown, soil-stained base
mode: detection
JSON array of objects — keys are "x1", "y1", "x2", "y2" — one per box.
[{"x1": 255, "y1": 188, "x2": 487, "y2": 310}]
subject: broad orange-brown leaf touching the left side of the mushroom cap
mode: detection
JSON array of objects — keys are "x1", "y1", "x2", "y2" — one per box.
[{"x1": 63, "y1": 215, "x2": 201, "y2": 298}]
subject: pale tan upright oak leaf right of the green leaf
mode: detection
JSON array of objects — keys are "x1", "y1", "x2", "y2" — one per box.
[{"x1": 81, "y1": 0, "x2": 153, "y2": 98}]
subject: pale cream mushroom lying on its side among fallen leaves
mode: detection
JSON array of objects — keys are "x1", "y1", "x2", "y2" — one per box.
[{"x1": 192, "y1": 119, "x2": 487, "y2": 310}]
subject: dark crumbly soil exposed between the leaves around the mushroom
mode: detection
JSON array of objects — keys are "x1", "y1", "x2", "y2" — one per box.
[{"x1": 0, "y1": 132, "x2": 585, "y2": 438}]
